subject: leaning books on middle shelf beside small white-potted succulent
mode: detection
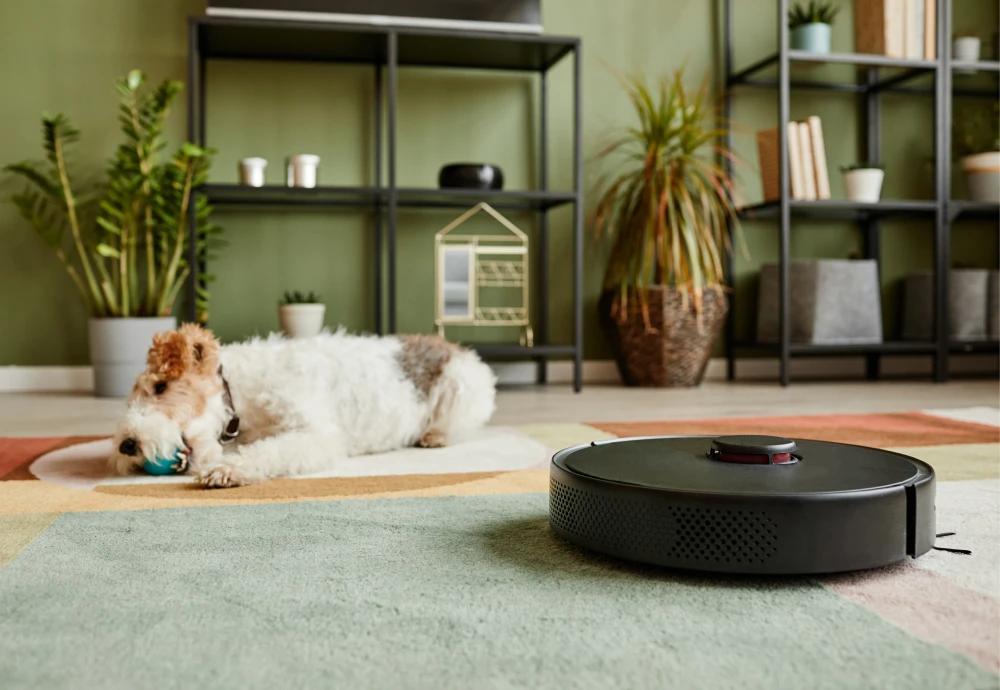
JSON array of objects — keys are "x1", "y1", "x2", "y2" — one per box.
[{"x1": 757, "y1": 115, "x2": 830, "y2": 201}]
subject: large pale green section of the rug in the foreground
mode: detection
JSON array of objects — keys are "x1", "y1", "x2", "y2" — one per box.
[{"x1": 0, "y1": 494, "x2": 997, "y2": 690}]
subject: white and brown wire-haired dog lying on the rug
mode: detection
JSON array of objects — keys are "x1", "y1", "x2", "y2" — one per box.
[{"x1": 110, "y1": 324, "x2": 496, "y2": 487}]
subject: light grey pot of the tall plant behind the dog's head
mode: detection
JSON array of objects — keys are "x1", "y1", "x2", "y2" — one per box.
[{"x1": 89, "y1": 316, "x2": 177, "y2": 398}]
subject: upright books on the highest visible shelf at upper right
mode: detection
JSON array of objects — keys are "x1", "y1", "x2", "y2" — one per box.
[{"x1": 854, "y1": 0, "x2": 937, "y2": 60}]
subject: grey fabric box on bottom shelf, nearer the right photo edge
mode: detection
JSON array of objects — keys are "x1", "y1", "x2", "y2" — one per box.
[{"x1": 901, "y1": 268, "x2": 996, "y2": 341}]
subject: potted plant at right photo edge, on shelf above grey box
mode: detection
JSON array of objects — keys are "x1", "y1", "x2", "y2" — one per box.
[{"x1": 952, "y1": 101, "x2": 1000, "y2": 204}]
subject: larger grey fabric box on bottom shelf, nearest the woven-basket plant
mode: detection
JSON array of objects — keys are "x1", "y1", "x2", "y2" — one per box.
[{"x1": 757, "y1": 259, "x2": 882, "y2": 345}]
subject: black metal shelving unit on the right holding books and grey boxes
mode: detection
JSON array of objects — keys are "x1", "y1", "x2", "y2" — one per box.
[{"x1": 722, "y1": 0, "x2": 1000, "y2": 386}]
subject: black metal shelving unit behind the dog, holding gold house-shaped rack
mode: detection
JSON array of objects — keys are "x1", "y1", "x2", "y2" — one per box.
[{"x1": 188, "y1": 17, "x2": 583, "y2": 391}]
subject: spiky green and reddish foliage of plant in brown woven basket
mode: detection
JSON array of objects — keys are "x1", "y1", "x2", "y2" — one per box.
[{"x1": 594, "y1": 71, "x2": 739, "y2": 329}]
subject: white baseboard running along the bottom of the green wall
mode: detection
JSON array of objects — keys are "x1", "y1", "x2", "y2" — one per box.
[{"x1": 0, "y1": 355, "x2": 997, "y2": 393}]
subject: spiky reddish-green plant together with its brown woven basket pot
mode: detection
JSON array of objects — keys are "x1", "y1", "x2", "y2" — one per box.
[{"x1": 594, "y1": 72, "x2": 738, "y2": 386}]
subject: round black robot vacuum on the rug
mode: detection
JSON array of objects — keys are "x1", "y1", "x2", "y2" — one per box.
[{"x1": 549, "y1": 436, "x2": 935, "y2": 575}]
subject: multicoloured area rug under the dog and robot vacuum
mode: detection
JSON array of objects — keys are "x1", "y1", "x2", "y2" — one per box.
[{"x1": 0, "y1": 408, "x2": 1000, "y2": 690}]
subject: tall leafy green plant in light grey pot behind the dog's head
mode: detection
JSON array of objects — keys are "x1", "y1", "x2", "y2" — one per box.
[{"x1": 5, "y1": 71, "x2": 219, "y2": 397}]
